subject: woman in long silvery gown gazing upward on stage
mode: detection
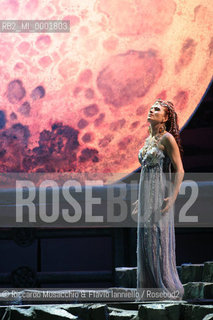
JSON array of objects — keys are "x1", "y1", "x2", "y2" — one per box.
[{"x1": 133, "y1": 99, "x2": 184, "y2": 300}]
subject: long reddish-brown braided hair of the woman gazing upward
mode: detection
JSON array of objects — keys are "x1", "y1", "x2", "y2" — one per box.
[{"x1": 156, "y1": 99, "x2": 183, "y2": 157}]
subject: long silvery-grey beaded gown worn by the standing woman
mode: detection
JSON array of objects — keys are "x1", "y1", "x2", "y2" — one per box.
[{"x1": 136, "y1": 137, "x2": 184, "y2": 300}]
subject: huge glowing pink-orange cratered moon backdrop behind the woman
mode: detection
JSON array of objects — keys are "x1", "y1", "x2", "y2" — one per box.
[{"x1": 0, "y1": 0, "x2": 213, "y2": 183}]
